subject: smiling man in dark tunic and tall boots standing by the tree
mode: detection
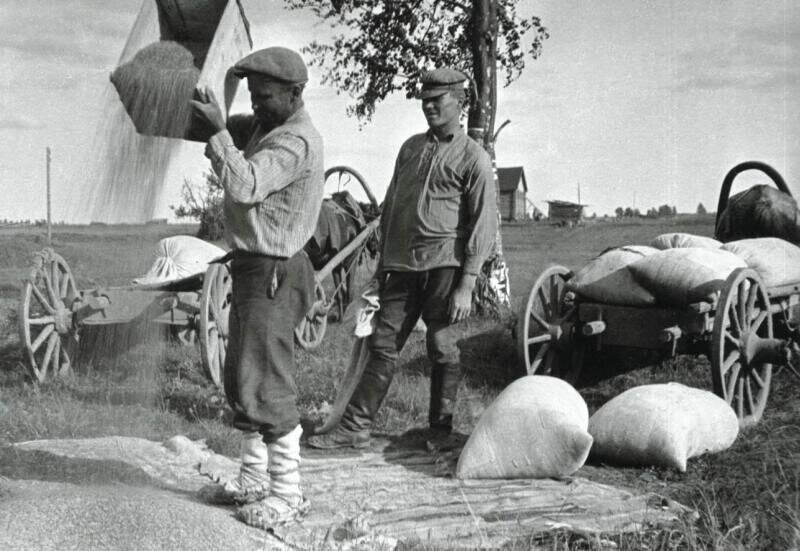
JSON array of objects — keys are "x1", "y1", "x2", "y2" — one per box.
[{"x1": 308, "y1": 68, "x2": 497, "y2": 449}]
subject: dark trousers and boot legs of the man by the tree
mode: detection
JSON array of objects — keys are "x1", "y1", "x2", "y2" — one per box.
[{"x1": 342, "y1": 267, "x2": 461, "y2": 431}]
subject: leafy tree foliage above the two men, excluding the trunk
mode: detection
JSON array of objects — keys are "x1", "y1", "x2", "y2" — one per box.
[{"x1": 285, "y1": 0, "x2": 549, "y2": 122}]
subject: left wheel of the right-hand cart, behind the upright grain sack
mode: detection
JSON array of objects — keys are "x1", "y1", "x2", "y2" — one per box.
[{"x1": 517, "y1": 266, "x2": 584, "y2": 384}]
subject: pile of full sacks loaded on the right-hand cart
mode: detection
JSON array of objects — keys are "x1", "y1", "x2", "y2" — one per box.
[{"x1": 567, "y1": 233, "x2": 800, "y2": 307}]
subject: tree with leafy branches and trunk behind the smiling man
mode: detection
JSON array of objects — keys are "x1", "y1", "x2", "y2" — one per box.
[{"x1": 285, "y1": 0, "x2": 549, "y2": 306}]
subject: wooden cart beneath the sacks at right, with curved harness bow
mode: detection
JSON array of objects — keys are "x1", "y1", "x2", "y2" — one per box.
[{"x1": 516, "y1": 162, "x2": 800, "y2": 427}]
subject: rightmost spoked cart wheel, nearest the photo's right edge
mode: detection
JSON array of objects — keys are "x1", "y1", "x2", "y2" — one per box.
[{"x1": 711, "y1": 268, "x2": 772, "y2": 428}]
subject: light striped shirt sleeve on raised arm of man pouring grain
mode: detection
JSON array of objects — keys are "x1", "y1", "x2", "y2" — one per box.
[{"x1": 206, "y1": 130, "x2": 308, "y2": 205}]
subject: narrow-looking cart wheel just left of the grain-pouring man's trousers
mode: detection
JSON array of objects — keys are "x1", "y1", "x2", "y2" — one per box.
[{"x1": 200, "y1": 264, "x2": 233, "y2": 388}]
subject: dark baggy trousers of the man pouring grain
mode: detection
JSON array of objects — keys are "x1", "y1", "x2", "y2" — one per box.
[{"x1": 224, "y1": 252, "x2": 314, "y2": 443}]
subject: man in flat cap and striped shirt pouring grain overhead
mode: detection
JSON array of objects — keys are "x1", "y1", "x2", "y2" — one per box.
[{"x1": 192, "y1": 47, "x2": 324, "y2": 529}]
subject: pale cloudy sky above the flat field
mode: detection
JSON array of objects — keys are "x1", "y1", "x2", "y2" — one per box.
[{"x1": 0, "y1": 0, "x2": 800, "y2": 222}]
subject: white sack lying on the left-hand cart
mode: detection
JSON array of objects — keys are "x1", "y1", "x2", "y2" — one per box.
[{"x1": 133, "y1": 235, "x2": 225, "y2": 285}]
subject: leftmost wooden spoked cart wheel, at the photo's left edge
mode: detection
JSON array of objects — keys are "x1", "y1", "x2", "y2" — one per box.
[{"x1": 19, "y1": 249, "x2": 79, "y2": 383}]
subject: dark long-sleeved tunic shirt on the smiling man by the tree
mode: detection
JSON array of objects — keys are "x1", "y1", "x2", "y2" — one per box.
[{"x1": 381, "y1": 131, "x2": 497, "y2": 274}]
